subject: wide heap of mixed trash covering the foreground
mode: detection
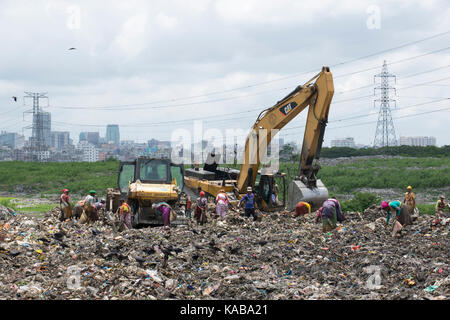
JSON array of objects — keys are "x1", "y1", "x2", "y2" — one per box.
[{"x1": 0, "y1": 207, "x2": 450, "y2": 300}]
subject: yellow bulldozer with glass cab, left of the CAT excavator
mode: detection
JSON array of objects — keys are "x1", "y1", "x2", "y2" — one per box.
[{"x1": 106, "y1": 157, "x2": 186, "y2": 228}]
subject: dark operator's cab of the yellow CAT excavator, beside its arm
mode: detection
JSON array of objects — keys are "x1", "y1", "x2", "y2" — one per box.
[{"x1": 255, "y1": 171, "x2": 286, "y2": 211}]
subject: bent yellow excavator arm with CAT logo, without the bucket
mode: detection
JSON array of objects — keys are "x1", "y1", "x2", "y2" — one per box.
[{"x1": 236, "y1": 67, "x2": 334, "y2": 209}]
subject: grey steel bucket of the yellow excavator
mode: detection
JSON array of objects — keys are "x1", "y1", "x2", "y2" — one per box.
[{"x1": 287, "y1": 180, "x2": 328, "y2": 212}]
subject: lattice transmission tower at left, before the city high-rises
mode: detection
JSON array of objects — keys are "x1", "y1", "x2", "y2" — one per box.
[{"x1": 24, "y1": 92, "x2": 48, "y2": 161}]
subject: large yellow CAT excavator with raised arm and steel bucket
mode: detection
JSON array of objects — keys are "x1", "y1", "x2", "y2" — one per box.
[{"x1": 184, "y1": 67, "x2": 334, "y2": 211}]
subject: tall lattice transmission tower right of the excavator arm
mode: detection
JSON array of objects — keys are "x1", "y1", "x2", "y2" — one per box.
[{"x1": 373, "y1": 60, "x2": 397, "y2": 148}]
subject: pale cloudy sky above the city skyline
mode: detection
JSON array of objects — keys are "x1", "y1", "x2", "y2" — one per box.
[{"x1": 0, "y1": 0, "x2": 450, "y2": 146}]
